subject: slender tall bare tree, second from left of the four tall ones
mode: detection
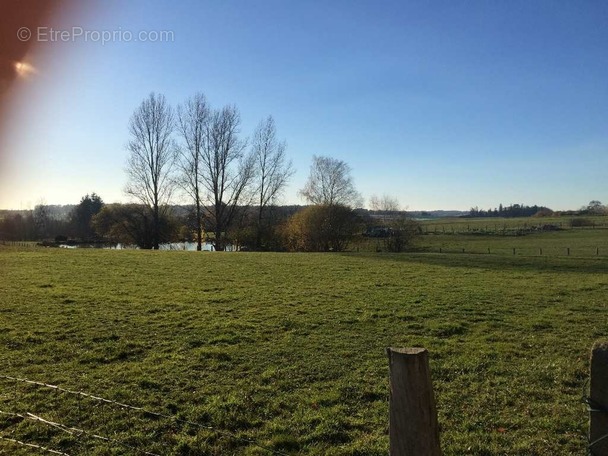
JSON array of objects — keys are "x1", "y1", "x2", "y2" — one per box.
[{"x1": 177, "y1": 93, "x2": 211, "y2": 251}]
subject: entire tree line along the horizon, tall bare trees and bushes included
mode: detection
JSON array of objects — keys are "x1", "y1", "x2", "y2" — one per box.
[{"x1": 0, "y1": 93, "x2": 606, "y2": 252}]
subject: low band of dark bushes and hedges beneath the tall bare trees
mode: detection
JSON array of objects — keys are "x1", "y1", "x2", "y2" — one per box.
[{"x1": 0, "y1": 194, "x2": 420, "y2": 252}]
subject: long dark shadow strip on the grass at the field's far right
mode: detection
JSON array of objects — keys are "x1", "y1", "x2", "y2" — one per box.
[{"x1": 350, "y1": 252, "x2": 608, "y2": 274}]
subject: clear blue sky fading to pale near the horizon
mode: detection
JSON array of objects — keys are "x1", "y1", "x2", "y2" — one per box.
[{"x1": 0, "y1": 0, "x2": 608, "y2": 210}]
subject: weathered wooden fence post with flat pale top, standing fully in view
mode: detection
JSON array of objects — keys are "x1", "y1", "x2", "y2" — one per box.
[{"x1": 386, "y1": 348, "x2": 441, "y2": 456}]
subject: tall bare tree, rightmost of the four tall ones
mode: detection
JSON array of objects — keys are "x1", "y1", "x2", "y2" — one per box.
[{"x1": 252, "y1": 116, "x2": 294, "y2": 248}]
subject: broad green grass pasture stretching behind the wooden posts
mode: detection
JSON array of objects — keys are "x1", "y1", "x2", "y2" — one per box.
[{"x1": 0, "y1": 235, "x2": 608, "y2": 455}]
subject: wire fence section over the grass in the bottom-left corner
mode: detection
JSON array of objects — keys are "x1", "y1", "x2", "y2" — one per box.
[{"x1": 0, "y1": 375, "x2": 287, "y2": 456}]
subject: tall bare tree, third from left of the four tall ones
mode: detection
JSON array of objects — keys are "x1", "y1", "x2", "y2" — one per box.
[{"x1": 200, "y1": 106, "x2": 254, "y2": 250}]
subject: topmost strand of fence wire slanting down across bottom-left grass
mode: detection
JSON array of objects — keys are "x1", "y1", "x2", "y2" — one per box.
[{"x1": 0, "y1": 375, "x2": 289, "y2": 456}]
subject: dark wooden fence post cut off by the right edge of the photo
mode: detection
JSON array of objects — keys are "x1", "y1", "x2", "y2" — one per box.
[{"x1": 589, "y1": 342, "x2": 608, "y2": 456}]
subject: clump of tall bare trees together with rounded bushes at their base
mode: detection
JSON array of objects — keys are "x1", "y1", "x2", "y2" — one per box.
[{"x1": 113, "y1": 93, "x2": 418, "y2": 251}]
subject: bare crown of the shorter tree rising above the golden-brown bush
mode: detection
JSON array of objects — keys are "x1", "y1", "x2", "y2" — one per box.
[{"x1": 300, "y1": 155, "x2": 361, "y2": 207}]
